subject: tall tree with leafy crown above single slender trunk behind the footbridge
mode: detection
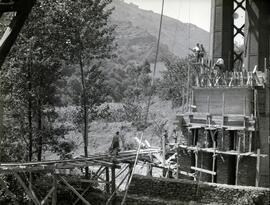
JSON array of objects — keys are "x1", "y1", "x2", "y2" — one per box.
[{"x1": 54, "y1": 0, "x2": 115, "y2": 174}]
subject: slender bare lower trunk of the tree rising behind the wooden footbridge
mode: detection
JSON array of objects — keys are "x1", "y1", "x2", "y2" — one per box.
[{"x1": 80, "y1": 54, "x2": 89, "y2": 177}]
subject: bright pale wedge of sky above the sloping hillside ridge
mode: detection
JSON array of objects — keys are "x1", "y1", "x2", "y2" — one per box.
[{"x1": 124, "y1": 0, "x2": 211, "y2": 31}]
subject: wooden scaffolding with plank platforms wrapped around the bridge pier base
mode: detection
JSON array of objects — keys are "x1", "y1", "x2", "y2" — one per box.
[{"x1": 171, "y1": 58, "x2": 269, "y2": 186}]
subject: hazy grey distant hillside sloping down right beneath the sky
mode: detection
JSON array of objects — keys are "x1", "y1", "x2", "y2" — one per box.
[{"x1": 111, "y1": 0, "x2": 209, "y2": 57}]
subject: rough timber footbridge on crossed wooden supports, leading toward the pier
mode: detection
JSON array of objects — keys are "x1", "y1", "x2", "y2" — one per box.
[{"x1": 0, "y1": 145, "x2": 160, "y2": 205}]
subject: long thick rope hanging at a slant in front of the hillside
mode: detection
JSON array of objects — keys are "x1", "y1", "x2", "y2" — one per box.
[{"x1": 145, "y1": 0, "x2": 164, "y2": 123}]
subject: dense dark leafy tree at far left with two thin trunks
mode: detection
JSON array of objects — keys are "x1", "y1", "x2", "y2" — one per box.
[{"x1": 1, "y1": 0, "x2": 66, "y2": 161}]
